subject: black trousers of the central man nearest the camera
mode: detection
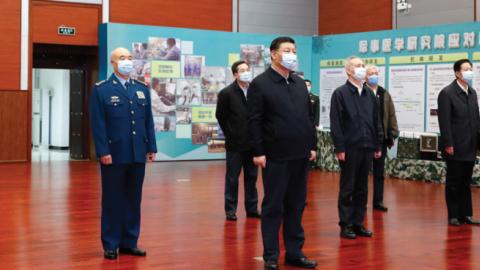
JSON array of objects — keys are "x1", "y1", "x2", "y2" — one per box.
[{"x1": 262, "y1": 158, "x2": 309, "y2": 260}]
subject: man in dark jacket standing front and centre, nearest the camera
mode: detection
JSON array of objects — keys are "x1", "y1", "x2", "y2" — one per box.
[{"x1": 247, "y1": 37, "x2": 317, "y2": 269}]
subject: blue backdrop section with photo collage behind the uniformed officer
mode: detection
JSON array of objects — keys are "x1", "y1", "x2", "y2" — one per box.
[{"x1": 99, "y1": 23, "x2": 313, "y2": 160}]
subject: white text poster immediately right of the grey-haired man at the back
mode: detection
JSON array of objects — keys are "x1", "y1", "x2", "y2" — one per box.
[{"x1": 388, "y1": 65, "x2": 425, "y2": 132}]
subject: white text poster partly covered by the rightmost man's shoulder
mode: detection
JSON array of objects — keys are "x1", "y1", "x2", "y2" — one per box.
[{"x1": 426, "y1": 64, "x2": 454, "y2": 133}]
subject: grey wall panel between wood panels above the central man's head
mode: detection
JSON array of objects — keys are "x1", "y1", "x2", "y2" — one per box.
[{"x1": 238, "y1": 0, "x2": 319, "y2": 35}]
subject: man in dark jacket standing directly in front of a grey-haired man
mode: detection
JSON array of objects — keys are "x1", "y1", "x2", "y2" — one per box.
[{"x1": 330, "y1": 57, "x2": 383, "y2": 239}]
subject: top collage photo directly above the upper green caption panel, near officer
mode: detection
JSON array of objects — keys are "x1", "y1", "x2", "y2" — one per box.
[{"x1": 147, "y1": 37, "x2": 182, "y2": 61}]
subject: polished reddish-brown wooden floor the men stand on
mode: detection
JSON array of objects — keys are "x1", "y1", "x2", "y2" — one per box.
[{"x1": 0, "y1": 161, "x2": 480, "y2": 270}]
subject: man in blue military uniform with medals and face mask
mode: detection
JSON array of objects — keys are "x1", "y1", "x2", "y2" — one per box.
[{"x1": 90, "y1": 48, "x2": 157, "y2": 260}]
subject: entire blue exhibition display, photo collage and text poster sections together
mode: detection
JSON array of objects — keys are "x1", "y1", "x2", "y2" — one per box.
[{"x1": 99, "y1": 23, "x2": 480, "y2": 160}]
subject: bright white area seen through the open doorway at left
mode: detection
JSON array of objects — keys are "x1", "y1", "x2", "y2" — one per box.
[{"x1": 37, "y1": 69, "x2": 70, "y2": 148}]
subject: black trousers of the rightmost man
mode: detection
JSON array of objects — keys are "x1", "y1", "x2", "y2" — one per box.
[{"x1": 445, "y1": 160, "x2": 474, "y2": 219}]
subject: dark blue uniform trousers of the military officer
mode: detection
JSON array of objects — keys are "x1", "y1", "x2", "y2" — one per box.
[{"x1": 100, "y1": 163, "x2": 145, "y2": 250}]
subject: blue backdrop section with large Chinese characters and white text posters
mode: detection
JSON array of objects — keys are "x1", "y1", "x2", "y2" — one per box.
[{"x1": 312, "y1": 23, "x2": 480, "y2": 132}]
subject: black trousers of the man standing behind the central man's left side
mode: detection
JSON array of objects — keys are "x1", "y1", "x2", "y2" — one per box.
[{"x1": 225, "y1": 151, "x2": 258, "y2": 213}]
